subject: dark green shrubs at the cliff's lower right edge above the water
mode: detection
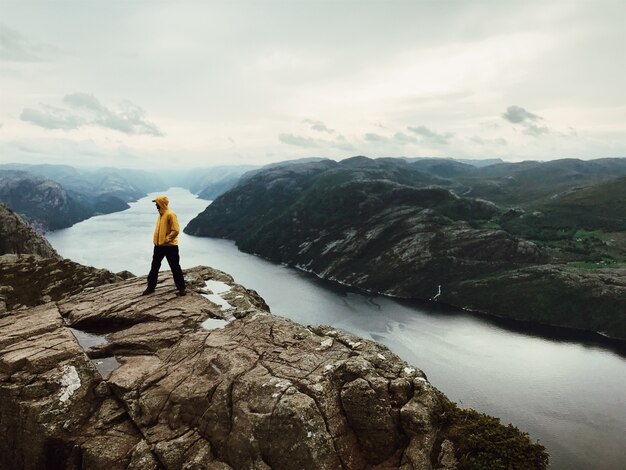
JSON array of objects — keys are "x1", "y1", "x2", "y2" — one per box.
[{"x1": 431, "y1": 394, "x2": 548, "y2": 470}]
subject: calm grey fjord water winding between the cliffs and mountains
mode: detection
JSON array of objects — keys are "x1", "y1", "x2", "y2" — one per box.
[{"x1": 47, "y1": 188, "x2": 626, "y2": 470}]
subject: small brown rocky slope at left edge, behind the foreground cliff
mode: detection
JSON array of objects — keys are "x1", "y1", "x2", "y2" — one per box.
[{"x1": 0, "y1": 202, "x2": 59, "y2": 258}]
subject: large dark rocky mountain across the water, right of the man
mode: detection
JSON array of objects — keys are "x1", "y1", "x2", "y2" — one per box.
[{"x1": 185, "y1": 157, "x2": 626, "y2": 339}]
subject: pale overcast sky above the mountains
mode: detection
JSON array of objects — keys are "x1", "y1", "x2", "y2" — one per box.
[{"x1": 0, "y1": 0, "x2": 626, "y2": 168}]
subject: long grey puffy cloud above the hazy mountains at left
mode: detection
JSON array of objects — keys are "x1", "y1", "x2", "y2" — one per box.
[{"x1": 20, "y1": 93, "x2": 164, "y2": 137}]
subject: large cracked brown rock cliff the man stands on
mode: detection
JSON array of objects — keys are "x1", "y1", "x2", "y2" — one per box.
[{"x1": 0, "y1": 268, "x2": 545, "y2": 470}]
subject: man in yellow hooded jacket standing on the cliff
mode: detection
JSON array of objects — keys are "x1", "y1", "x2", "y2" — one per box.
[{"x1": 142, "y1": 195, "x2": 186, "y2": 295}]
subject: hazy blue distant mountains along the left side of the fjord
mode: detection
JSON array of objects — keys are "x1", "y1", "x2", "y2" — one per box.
[{"x1": 0, "y1": 164, "x2": 257, "y2": 232}]
